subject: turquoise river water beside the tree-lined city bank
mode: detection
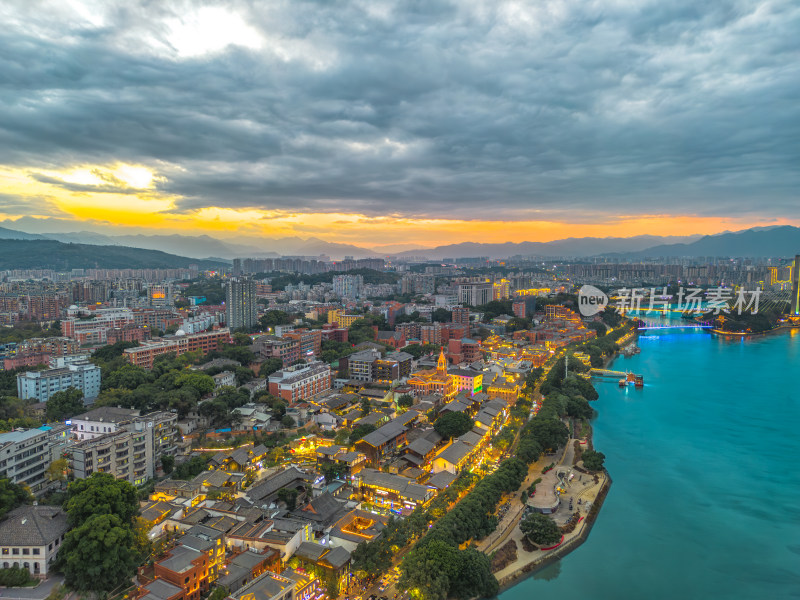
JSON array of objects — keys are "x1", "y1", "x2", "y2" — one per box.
[{"x1": 501, "y1": 331, "x2": 800, "y2": 600}]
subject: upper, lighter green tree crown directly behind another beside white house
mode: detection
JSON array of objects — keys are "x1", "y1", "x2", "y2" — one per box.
[{"x1": 64, "y1": 473, "x2": 139, "y2": 527}]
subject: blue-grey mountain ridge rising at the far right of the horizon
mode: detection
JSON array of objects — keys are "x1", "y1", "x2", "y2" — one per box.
[{"x1": 625, "y1": 225, "x2": 800, "y2": 258}]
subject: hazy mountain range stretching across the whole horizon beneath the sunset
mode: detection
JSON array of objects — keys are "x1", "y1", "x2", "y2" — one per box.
[{"x1": 0, "y1": 221, "x2": 800, "y2": 261}]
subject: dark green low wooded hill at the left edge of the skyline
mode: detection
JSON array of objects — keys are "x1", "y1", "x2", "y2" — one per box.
[{"x1": 0, "y1": 239, "x2": 226, "y2": 271}]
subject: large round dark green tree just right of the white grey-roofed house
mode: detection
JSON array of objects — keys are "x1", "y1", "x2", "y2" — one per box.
[{"x1": 58, "y1": 513, "x2": 139, "y2": 592}]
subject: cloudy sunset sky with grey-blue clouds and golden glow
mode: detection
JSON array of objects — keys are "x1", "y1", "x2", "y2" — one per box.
[{"x1": 0, "y1": 0, "x2": 800, "y2": 249}]
